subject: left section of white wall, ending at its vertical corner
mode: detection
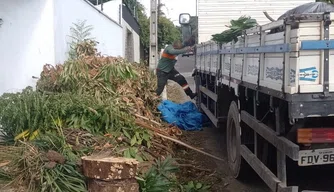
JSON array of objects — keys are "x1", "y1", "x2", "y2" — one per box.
[{"x1": 0, "y1": 0, "x2": 55, "y2": 95}]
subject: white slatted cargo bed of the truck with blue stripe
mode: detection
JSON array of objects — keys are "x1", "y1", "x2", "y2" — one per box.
[{"x1": 195, "y1": 14, "x2": 334, "y2": 94}]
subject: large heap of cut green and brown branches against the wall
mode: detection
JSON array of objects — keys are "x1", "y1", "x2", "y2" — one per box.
[{"x1": 0, "y1": 27, "x2": 181, "y2": 192}]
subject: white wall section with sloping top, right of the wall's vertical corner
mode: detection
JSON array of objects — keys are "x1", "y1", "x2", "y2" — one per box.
[{"x1": 54, "y1": 0, "x2": 124, "y2": 63}]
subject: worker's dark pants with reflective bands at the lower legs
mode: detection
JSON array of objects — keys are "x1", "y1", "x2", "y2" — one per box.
[{"x1": 156, "y1": 69, "x2": 195, "y2": 98}]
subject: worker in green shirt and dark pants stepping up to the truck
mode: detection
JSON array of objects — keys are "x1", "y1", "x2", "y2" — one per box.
[{"x1": 156, "y1": 40, "x2": 196, "y2": 99}]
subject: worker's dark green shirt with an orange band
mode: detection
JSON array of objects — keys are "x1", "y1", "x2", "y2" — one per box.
[{"x1": 157, "y1": 45, "x2": 188, "y2": 73}]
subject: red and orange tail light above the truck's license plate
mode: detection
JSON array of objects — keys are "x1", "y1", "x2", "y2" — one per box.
[{"x1": 297, "y1": 128, "x2": 334, "y2": 144}]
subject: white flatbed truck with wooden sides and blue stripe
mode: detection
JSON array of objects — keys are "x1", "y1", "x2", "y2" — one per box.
[{"x1": 180, "y1": 13, "x2": 334, "y2": 192}]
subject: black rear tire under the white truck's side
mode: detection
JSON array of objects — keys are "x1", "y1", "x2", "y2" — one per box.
[{"x1": 226, "y1": 101, "x2": 247, "y2": 179}]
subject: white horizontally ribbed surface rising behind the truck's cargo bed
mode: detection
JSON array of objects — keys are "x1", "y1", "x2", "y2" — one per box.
[{"x1": 197, "y1": 0, "x2": 315, "y2": 42}]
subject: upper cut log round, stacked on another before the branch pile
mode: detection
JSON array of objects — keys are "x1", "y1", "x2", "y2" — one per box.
[{"x1": 81, "y1": 156, "x2": 138, "y2": 181}]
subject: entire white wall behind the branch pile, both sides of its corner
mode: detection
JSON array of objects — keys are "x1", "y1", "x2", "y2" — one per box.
[{"x1": 0, "y1": 0, "x2": 124, "y2": 95}]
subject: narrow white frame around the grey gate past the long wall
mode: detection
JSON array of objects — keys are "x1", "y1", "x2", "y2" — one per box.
[{"x1": 122, "y1": 19, "x2": 140, "y2": 63}]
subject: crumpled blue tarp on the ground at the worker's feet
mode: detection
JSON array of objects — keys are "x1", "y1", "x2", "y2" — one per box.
[{"x1": 158, "y1": 100, "x2": 204, "y2": 131}]
